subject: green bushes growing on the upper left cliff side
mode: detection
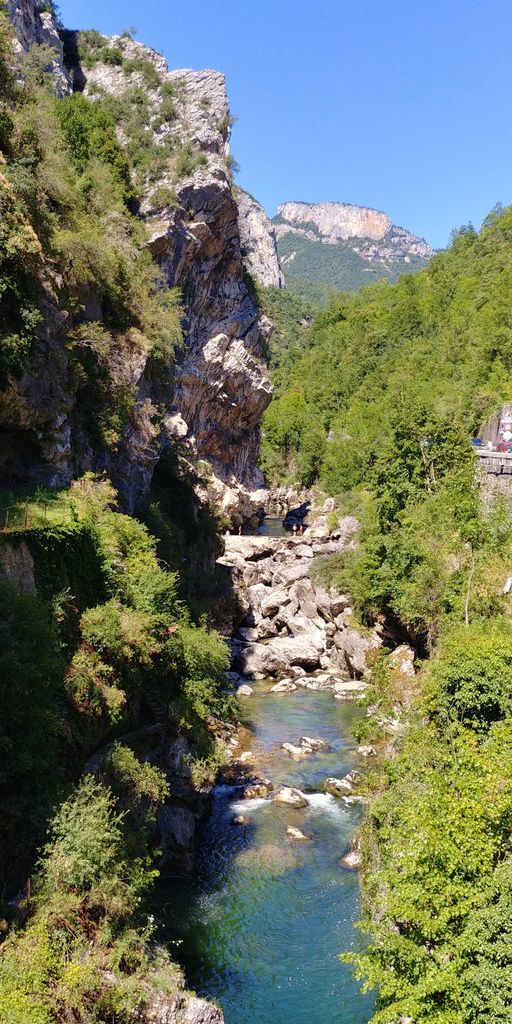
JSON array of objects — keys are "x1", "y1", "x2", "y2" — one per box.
[{"x1": 0, "y1": 20, "x2": 181, "y2": 403}]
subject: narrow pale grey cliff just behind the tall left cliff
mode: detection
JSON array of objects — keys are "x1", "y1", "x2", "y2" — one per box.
[{"x1": 236, "y1": 188, "x2": 285, "y2": 288}]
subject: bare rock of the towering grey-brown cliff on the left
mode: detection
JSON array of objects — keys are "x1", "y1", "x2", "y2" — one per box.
[{"x1": 0, "y1": 14, "x2": 271, "y2": 521}]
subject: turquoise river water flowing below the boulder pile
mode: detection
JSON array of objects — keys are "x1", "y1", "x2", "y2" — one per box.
[{"x1": 159, "y1": 683, "x2": 372, "y2": 1024}]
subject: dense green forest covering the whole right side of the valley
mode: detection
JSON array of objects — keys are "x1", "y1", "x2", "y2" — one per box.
[{"x1": 262, "y1": 208, "x2": 512, "y2": 1024}]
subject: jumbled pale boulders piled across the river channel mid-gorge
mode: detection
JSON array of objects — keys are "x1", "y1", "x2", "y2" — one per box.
[{"x1": 220, "y1": 516, "x2": 382, "y2": 684}]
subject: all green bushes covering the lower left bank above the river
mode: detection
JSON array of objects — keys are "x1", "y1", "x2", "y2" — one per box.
[{"x1": 0, "y1": 478, "x2": 232, "y2": 1024}]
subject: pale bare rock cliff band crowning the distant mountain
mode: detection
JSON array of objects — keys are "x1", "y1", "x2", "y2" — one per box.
[{"x1": 274, "y1": 197, "x2": 434, "y2": 259}]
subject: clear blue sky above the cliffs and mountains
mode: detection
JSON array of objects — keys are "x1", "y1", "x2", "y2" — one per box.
[{"x1": 59, "y1": 0, "x2": 512, "y2": 247}]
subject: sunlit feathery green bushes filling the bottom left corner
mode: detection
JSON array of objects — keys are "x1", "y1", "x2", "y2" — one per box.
[{"x1": 0, "y1": 769, "x2": 179, "y2": 1024}]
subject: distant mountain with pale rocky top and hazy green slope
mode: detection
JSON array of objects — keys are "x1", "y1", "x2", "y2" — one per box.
[{"x1": 272, "y1": 202, "x2": 435, "y2": 291}]
